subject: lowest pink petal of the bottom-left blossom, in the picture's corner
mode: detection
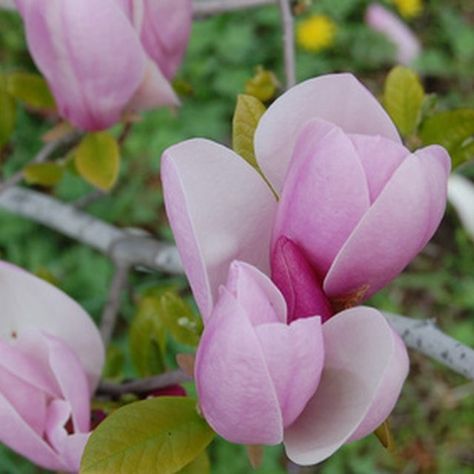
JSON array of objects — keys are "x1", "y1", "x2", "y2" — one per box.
[{"x1": 0, "y1": 392, "x2": 65, "y2": 471}]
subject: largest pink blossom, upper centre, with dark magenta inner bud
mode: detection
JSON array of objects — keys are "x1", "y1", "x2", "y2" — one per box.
[{"x1": 162, "y1": 74, "x2": 450, "y2": 321}]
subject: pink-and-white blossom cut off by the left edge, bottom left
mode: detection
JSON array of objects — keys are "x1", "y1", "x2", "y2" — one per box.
[{"x1": 0, "y1": 262, "x2": 104, "y2": 472}]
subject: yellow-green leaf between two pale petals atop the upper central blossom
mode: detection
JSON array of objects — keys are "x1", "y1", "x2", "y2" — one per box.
[{"x1": 232, "y1": 94, "x2": 266, "y2": 169}]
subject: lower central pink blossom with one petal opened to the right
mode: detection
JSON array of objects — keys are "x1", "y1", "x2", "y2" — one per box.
[{"x1": 195, "y1": 262, "x2": 408, "y2": 464}]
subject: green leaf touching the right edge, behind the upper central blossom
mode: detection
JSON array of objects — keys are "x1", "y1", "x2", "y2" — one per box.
[{"x1": 420, "y1": 109, "x2": 474, "y2": 167}]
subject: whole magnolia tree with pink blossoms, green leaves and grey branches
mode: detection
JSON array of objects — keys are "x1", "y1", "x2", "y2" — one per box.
[{"x1": 0, "y1": 0, "x2": 474, "y2": 474}]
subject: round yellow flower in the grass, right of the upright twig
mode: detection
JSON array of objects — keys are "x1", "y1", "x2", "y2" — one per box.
[{"x1": 296, "y1": 15, "x2": 336, "y2": 52}]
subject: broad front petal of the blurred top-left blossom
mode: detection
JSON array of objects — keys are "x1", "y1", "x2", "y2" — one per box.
[{"x1": 18, "y1": 0, "x2": 145, "y2": 130}]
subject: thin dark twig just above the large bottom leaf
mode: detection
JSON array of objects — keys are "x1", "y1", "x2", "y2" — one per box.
[{"x1": 97, "y1": 370, "x2": 191, "y2": 397}]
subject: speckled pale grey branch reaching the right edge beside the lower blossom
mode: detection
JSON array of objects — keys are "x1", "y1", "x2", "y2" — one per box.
[{"x1": 384, "y1": 313, "x2": 474, "y2": 380}]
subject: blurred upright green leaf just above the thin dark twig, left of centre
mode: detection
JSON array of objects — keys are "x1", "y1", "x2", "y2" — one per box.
[{"x1": 129, "y1": 296, "x2": 166, "y2": 377}]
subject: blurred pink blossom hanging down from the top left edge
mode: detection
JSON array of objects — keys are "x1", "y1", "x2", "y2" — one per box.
[{"x1": 16, "y1": 0, "x2": 191, "y2": 130}]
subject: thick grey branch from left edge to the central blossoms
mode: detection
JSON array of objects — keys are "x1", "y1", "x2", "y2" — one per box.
[{"x1": 0, "y1": 186, "x2": 183, "y2": 274}]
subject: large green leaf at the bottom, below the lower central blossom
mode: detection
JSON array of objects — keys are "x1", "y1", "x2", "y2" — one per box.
[{"x1": 80, "y1": 397, "x2": 214, "y2": 474}]
